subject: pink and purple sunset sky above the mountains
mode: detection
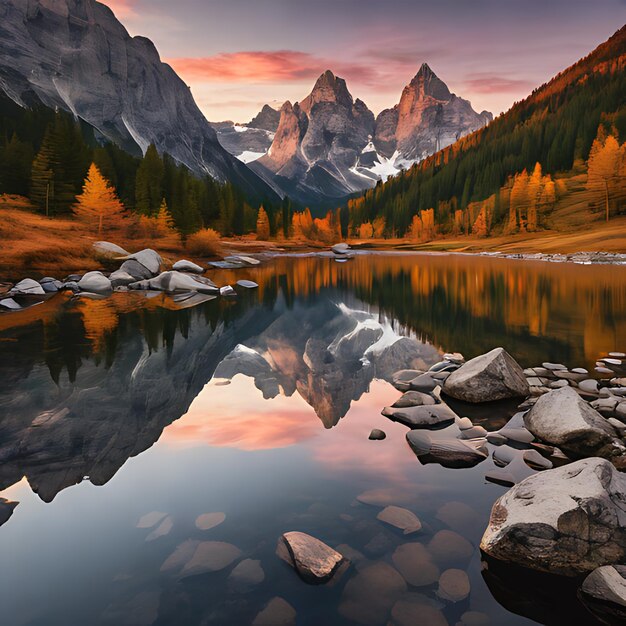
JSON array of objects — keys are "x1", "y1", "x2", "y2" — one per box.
[{"x1": 107, "y1": 0, "x2": 626, "y2": 122}]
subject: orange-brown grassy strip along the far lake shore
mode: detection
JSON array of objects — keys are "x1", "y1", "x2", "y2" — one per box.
[{"x1": 0, "y1": 197, "x2": 626, "y2": 281}]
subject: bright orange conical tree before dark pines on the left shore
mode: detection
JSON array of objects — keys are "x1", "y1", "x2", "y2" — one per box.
[{"x1": 73, "y1": 163, "x2": 126, "y2": 236}]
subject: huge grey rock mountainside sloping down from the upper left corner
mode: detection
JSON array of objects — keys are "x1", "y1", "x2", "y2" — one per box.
[{"x1": 0, "y1": 0, "x2": 273, "y2": 196}]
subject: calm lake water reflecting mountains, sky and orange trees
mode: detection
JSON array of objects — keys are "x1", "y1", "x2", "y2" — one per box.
[{"x1": 0, "y1": 254, "x2": 626, "y2": 626}]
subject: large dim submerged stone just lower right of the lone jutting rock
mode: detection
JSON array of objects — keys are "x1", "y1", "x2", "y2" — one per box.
[{"x1": 339, "y1": 562, "x2": 406, "y2": 626}]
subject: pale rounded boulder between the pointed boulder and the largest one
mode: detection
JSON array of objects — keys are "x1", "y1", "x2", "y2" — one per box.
[{"x1": 524, "y1": 387, "x2": 617, "y2": 454}]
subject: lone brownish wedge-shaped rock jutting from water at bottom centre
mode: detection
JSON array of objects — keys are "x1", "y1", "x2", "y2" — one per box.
[{"x1": 282, "y1": 531, "x2": 344, "y2": 583}]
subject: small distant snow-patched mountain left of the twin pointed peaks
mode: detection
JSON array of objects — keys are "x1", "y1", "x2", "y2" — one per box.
[{"x1": 211, "y1": 104, "x2": 280, "y2": 163}]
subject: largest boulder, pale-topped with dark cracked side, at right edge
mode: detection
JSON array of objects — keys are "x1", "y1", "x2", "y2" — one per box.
[{"x1": 480, "y1": 458, "x2": 626, "y2": 576}]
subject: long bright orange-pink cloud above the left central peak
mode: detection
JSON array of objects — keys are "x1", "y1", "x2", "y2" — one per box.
[{"x1": 167, "y1": 50, "x2": 378, "y2": 83}]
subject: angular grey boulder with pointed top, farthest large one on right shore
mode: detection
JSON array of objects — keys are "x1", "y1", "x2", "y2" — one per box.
[{"x1": 443, "y1": 348, "x2": 529, "y2": 403}]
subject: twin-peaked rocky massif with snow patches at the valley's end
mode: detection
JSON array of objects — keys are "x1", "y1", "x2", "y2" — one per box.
[{"x1": 243, "y1": 69, "x2": 492, "y2": 205}]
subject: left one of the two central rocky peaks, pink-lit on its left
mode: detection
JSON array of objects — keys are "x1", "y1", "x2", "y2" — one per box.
[{"x1": 250, "y1": 70, "x2": 374, "y2": 203}]
